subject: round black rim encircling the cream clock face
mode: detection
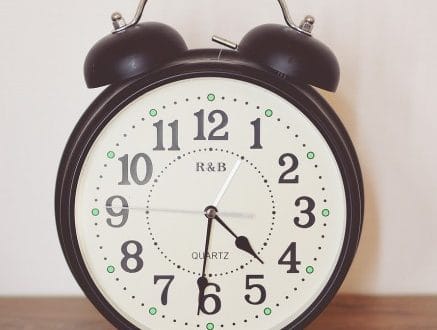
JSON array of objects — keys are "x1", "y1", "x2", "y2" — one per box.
[{"x1": 55, "y1": 49, "x2": 364, "y2": 329}]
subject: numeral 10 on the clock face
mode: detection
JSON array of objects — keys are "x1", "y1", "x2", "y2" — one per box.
[{"x1": 118, "y1": 154, "x2": 153, "y2": 185}]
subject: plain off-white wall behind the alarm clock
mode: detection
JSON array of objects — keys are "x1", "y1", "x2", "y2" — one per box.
[{"x1": 0, "y1": 0, "x2": 437, "y2": 295}]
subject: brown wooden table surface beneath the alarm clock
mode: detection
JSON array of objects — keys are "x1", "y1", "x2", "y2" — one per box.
[{"x1": 0, "y1": 295, "x2": 437, "y2": 330}]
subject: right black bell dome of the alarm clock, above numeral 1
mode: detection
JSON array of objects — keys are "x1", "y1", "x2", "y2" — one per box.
[{"x1": 238, "y1": 0, "x2": 340, "y2": 92}]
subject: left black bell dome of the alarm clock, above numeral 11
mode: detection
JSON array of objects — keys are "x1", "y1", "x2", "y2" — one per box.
[{"x1": 84, "y1": 0, "x2": 187, "y2": 88}]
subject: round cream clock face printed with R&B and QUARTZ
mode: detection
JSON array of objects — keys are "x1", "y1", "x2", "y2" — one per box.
[{"x1": 75, "y1": 78, "x2": 347, "y2": 330}]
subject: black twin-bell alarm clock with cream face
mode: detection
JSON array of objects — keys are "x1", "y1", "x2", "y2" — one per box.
[{"x1": 55, "y1": 0, "x2": 363, "y2": 330}]
